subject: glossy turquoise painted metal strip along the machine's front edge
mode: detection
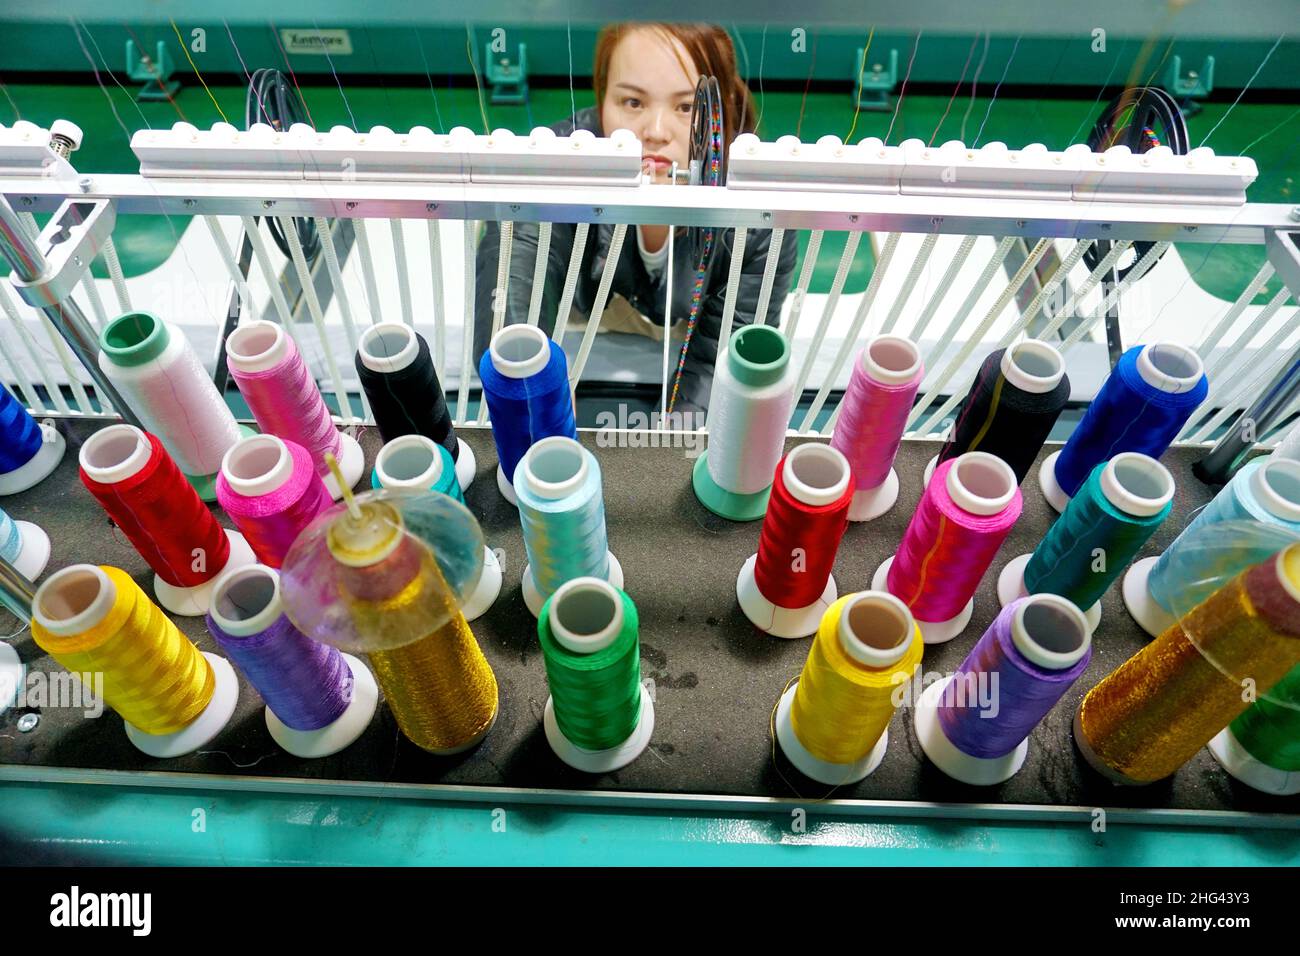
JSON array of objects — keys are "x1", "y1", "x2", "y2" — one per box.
[{"x1": 0, "y1": 784, "x2": 1300, "y2": 866}]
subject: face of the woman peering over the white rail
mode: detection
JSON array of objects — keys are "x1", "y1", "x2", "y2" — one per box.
[{"x1": 601, "y1": 30, "x2": 699, "y2": 182}]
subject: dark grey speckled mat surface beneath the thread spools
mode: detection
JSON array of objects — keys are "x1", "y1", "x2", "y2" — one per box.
[{"x1": 0, "y1": 420, "x2": 1300, "y2": 826}]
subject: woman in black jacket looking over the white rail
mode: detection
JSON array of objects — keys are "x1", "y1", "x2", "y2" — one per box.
[{"x1": 475, "y1": 23, "x2": 797, "y2": 416}]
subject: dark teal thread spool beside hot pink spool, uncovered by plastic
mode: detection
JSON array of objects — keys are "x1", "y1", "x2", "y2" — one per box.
[{"x1": 997, "y1": 451, "x2": 1174, "y2": 632}]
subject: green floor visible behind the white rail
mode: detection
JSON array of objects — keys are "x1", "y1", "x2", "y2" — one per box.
[{"x1": 0, "y1": 78, "x2": 1300, "y2": 302}]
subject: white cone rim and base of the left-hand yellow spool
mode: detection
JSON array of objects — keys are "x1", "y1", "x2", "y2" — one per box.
[{"x1": 31, "y1": 564, "x2": 239, "y2": 757}]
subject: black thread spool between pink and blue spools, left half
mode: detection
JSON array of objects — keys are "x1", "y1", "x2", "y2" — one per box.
[{"x1": 355, "y1": 323, "x2": 478, "y2": 490}]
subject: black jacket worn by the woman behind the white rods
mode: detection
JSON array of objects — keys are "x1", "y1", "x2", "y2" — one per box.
[{"x1": 475, "y1": 107, "x2": 798, "y2": 411}]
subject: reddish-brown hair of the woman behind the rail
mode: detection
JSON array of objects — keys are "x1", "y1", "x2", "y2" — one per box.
[{"x1": 592, "y1": 22, "x2": 757, "y2": 147}]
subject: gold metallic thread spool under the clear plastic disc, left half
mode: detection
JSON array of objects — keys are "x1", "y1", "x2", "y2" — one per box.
[{"x1": 326, "y1": 502, "x2": 498, "y2": 754}]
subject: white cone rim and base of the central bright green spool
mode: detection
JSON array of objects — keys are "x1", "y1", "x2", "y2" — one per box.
[{"x1": 542, "y1": 578, "x2": 654, "y2": 774}]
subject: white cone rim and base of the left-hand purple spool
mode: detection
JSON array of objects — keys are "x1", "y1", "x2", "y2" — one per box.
[{"x1": 211, "y1": 564, "x2": 380, "y2": 760}]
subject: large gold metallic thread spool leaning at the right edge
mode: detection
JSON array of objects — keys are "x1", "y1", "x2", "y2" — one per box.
[{"x1": 1074, "y1": 545, "x2": 1300, "y2": 784}]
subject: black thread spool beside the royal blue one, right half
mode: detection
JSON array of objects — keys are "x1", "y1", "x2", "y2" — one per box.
[{"x1": 926, "y1": 338, "x2": 1070, "y2": 484}]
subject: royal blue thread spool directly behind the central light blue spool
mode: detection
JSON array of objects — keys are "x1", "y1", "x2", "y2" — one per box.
[{"x1": 478, "y1": 323, "x2": 577, "y2": 509}]
